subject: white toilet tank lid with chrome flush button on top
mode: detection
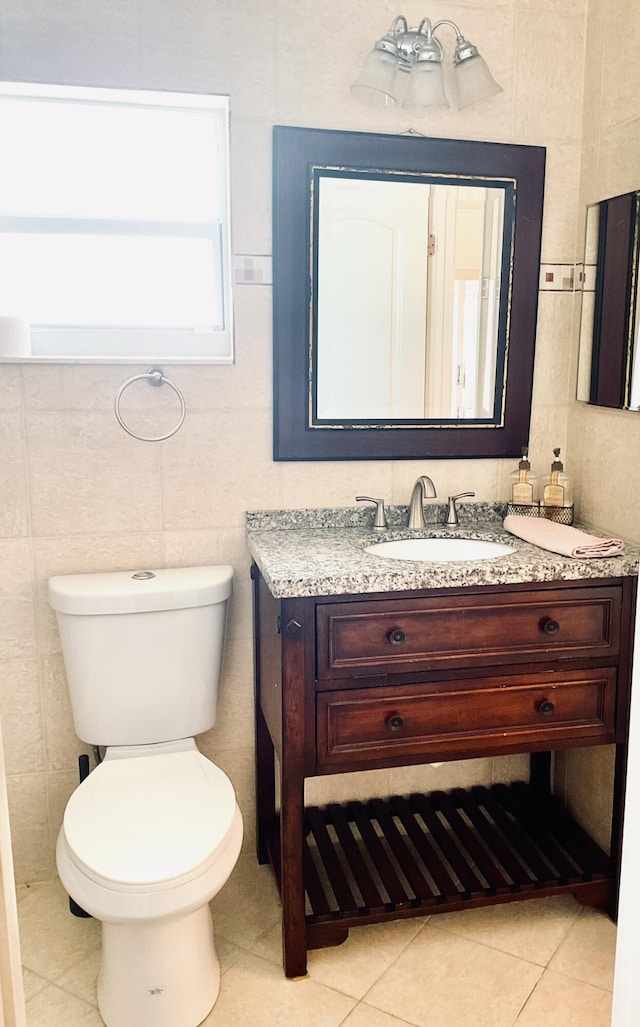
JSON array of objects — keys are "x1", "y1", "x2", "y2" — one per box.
[{"x1": 48, "y1": 564, "x2": 233, "y2": 615}]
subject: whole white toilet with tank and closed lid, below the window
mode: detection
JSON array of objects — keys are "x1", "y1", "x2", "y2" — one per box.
[{"x1": 48, "y1": 566, "x2": 242, "y2": 1027}]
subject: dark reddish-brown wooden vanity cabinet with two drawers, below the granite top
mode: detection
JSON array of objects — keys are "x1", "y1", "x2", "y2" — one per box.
[{"x1": 252, "y1": 566, "x2": 635, "y2": 977}]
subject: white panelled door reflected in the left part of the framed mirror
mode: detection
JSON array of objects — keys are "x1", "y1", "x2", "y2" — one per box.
[{"x1": 316, "y1": 178, "x2": 428, "y2": 420}]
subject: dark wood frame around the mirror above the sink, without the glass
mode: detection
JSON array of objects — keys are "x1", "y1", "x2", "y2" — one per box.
[{"x1": 273, "y1": 125, "x2": 545, "y2": 460}]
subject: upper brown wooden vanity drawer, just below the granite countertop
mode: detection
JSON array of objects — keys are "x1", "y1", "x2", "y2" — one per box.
[{"x1": 316, "y1": 586, "x2": 622, "y2": 681}]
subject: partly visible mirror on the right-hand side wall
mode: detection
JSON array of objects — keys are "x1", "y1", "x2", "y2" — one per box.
[{"x1": 577, "y1": 191, "x2": 640, "y2": 410}]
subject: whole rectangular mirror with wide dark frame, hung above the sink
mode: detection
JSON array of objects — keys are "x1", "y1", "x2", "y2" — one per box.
[{"x1": 273, "y1": 126, "x2": 544, "y2": 460}]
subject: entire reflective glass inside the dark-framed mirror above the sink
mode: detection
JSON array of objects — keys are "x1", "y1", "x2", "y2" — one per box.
[{"x1": 315, "y1": 176, "x2": 504, "y2": 422}]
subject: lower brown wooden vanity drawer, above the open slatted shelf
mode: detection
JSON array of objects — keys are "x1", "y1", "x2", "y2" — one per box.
[{"x1": 316, "y1": 668, "x2": 616, "y2": 771}]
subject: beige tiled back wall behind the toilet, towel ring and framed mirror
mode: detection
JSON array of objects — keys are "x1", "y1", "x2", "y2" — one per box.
[{"x1": 0, "y1": 0, "x2": 616, "y2": 881}]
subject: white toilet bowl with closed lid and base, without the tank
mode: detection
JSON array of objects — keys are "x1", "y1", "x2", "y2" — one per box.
[{"x1": 57, "y1": 739, "x2": 242, "y2": 1027}]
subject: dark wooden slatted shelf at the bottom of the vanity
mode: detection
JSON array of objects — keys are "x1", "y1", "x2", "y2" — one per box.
[{"x1": 287, "y1": 782, "x2": 614, "y2": 947}]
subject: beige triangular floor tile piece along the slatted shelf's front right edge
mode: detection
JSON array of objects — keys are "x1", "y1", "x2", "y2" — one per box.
[{"x1": 430, "y1": 896, "x2": 580, "y2": 966}]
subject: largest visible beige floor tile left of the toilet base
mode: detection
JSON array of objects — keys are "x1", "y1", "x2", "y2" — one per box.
[{"x1": 17, "y1": 879, "x2": 101, "y2": 982}]
